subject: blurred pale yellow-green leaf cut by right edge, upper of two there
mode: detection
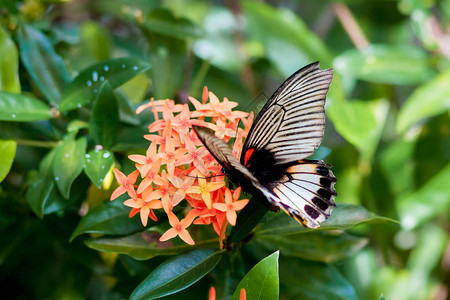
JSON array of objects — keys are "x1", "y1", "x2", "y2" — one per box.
[{"x1": 397, "y1": 69, "x2": 450, "y2": 134}]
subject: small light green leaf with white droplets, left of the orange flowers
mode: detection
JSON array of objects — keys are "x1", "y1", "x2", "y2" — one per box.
[{"x1": 84, "y1": 149, "x2": 114, "y2": 188}]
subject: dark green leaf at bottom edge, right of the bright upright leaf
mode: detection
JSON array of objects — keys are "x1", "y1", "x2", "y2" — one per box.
[{"x1": 280, "y1": 257, "x2": 361, "y2": 300}]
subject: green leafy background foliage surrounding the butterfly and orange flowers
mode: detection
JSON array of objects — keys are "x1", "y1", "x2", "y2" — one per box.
[{"x1": 0, "y1": 0, "x2": 450, "y2": 299}]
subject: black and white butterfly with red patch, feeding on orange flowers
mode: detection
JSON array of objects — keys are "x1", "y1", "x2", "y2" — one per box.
[{"x1": 193, "y1": 62, "x2": 337, "y2": 228}]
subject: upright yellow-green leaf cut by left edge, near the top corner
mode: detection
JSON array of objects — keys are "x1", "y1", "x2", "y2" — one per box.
[{"x1": 0, "y1": 26, "x2": 21, "y2": 93}]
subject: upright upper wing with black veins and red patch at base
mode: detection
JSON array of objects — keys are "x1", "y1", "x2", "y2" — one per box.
[{"x1": 241, "y1": 62, "x2": 333, "y2": 165}]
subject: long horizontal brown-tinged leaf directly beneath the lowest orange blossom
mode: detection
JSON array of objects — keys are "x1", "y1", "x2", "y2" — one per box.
[{"x1": 86, "y1": 230, "x2": 219, "y2": 260}]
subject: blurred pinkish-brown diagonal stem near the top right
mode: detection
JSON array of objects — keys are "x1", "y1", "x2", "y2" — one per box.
[{"x1": 333, "y1": 3, "x2": 369, "y2": 50}]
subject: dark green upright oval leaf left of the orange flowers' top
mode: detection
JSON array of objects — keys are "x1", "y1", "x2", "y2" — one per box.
[{"x1": 89, "y1": 82, "x2": 119, "y2": 148}]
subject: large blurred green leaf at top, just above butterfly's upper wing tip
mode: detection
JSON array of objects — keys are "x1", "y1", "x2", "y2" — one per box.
[{"x1": 243, "y1": 1, "x2": 332, "y2": 76}]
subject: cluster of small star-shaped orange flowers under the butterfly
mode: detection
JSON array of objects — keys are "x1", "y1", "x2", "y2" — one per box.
[{"x1": 111, "y1": 88, "x2": 253, "y2": 245}]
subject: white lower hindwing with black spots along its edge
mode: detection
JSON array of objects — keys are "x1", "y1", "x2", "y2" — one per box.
[{"x1": 259, "y1": 160, "x2": 336, "y2": 228}]
